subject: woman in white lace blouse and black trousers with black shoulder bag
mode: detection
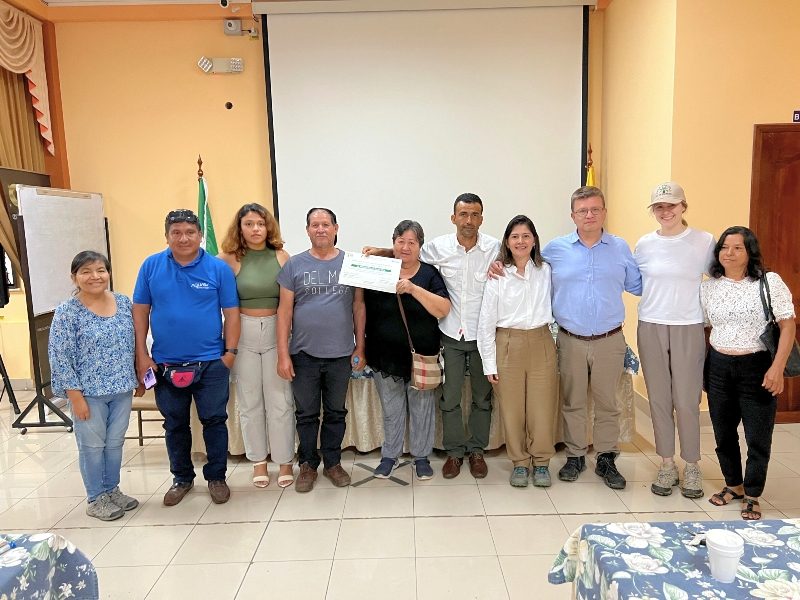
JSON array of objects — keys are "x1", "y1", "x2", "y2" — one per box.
[{"x1": 700, "y1": 227, "x2": 795, "y2": 521}]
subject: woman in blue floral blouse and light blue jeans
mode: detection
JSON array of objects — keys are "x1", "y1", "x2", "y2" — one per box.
[{"x1": 49, "y1": 250, "x2": 144, "y2": 521}]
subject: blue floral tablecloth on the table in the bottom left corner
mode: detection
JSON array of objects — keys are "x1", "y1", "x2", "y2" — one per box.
[{"x1": 0, "y1": 533, "x2": 99, "y2": 600}]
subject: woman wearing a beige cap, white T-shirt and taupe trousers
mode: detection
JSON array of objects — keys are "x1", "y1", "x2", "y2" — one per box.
[{"x1": 634, "y1": 182, "x2": 715, "y2": 498}]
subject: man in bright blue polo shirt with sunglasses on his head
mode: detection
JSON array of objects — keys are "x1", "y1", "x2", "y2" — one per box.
[{"x1": 133, "y1": 209, "x2": 239, "y2": 506}]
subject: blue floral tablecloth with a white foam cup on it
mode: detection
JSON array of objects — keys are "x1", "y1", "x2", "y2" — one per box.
[{"x1": 548, "y1": 519, "x2": 800, "y2": 600}]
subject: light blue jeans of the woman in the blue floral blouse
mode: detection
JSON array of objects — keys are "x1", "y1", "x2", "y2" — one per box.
[{"x1": 72, "y1": 391, "x2": 133, "y2": 502}]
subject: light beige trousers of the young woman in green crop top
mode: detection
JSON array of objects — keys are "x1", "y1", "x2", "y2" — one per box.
[{"x1": 233, "y1": 315, "x2": 295, "y2": 465}]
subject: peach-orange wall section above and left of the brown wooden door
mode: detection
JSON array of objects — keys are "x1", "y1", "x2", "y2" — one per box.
[{"x1": 672, "y1": 0, "x2": 800, "y2": 233}]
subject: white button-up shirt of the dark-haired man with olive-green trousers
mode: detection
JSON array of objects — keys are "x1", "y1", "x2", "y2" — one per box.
[{"x1": 419, "y1": 232, "x2": 500, "y2": 341}]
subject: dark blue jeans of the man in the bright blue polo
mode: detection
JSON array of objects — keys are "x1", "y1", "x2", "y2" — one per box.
[{"x1": 156, "y1": 359, "x2": 230, "y2": 483}]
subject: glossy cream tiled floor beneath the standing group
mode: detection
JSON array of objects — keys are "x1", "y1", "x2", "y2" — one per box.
[{"x1": 0, "y1": 393, "x2": 800, "y2": 600}]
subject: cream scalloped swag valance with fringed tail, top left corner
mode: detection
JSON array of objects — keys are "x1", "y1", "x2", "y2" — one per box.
[{"x1": 0, "y1": 0, "x2": 55, "y2": 155}]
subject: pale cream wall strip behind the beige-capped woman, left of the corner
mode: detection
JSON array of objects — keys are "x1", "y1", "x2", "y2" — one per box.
[{"x1": 596, "y1": 0, "x2": 676, "y2": 392}]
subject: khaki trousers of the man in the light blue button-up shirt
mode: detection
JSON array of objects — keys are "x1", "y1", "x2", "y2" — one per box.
[{"x1": 558, "y1": 331, "x2": 627, "y2": 456}]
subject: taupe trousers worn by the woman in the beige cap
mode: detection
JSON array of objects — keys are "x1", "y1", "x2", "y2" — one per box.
[{"x1": 637, "y1": 321, "x2": 706, "y2": 462}]
